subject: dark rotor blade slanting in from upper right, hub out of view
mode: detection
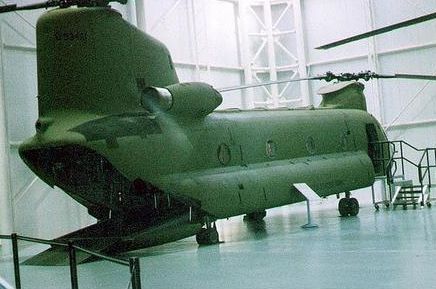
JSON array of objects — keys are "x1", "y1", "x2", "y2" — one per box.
[{"x1": 315, "y1": 12, "x2": 436, "y2": 49}]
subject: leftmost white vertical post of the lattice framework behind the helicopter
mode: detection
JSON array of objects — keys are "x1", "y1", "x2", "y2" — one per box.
[{"x1": 238, "y1": 0, "x2": 254, "y2": 109}]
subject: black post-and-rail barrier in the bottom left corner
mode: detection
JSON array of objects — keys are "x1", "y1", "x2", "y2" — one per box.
[{"x1": 0, "y1": 233, "x2": 141, "y2": 289}]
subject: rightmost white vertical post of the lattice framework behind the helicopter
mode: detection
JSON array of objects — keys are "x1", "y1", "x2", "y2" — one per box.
[{"x1": 292, "y1": 0, "x2": 313, "y2": 106}]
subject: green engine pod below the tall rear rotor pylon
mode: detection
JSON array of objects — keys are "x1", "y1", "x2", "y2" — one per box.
[{"x1": 141, "y1": 82, "x2": 223, "y2": 118}]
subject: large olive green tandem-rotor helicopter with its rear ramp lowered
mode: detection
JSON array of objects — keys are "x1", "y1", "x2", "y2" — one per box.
[{"x1": 0, "y1": 0, "x2": 435, "y2": 264}]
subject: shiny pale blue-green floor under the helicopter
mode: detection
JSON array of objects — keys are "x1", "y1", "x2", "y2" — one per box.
[{"x1": 0, "y1": 198, "x2": 436, "y2": 289}]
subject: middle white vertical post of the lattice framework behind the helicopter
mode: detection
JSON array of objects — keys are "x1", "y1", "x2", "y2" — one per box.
[{"x1": 263, "y1": 0, "x2": 279, "y2": 107}]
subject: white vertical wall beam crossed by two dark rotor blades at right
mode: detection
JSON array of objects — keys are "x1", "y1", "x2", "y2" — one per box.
[{"x1": 364, "y1": 0, "x2": 385, "y2": 123}]
